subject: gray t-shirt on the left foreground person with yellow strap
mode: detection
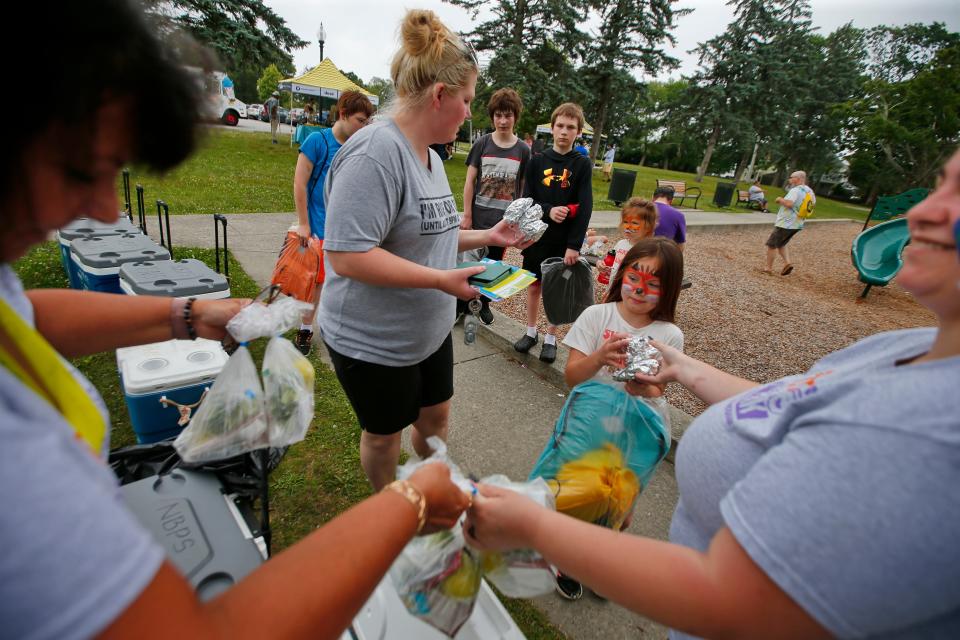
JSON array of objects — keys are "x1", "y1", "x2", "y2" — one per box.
[{"x1": 0, "y1": 265, "x2": 164, "y2": 640}]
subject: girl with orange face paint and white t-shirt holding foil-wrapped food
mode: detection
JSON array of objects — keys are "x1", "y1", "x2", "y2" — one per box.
[{"x1": 563, "y1": 237, "x2": 683, "y2": 396}]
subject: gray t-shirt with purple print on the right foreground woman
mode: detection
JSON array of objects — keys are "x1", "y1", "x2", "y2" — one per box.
[{"x1": 670, "y1": 329, "x2": 960, "y2": 638}]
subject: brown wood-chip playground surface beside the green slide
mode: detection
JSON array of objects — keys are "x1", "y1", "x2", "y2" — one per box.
[{"x1": 495, "y1": 223, "x2": 936, "y2": 416}]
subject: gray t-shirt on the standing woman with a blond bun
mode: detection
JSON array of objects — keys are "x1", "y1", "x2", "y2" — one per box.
[{"x1": 318, "y1": 120, "x2": 460, "y2": 367}]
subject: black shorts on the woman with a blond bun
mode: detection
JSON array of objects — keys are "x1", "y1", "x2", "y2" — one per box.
[{"x1": 327, "y1": 334, "x2": 453, "y2": 436}]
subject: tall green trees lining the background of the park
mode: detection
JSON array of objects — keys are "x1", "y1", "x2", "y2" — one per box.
[{"x1": 148, "y1": 0, "x2": 960, "y2": 202}]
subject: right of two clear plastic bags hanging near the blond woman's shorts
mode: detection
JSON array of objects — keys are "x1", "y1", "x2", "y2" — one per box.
[{"x1": 261, "y1": 336, "x2": 316, "y2": 447}]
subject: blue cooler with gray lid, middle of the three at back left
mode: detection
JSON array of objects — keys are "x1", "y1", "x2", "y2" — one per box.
[{"x1": 70, "y1": 233, "x2": 170, "y2": 293}]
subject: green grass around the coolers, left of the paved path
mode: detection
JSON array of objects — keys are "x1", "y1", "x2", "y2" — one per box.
[{"x1": 14, "y1": 242, "x2": 566, "y2": 640}]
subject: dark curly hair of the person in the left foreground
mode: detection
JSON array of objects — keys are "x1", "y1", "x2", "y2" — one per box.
[{"x1": 0, "y1": 0, "x2": 204, "y2": 200}]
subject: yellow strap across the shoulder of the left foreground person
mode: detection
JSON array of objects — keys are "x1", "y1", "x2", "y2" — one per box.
[{"x1": 0, "y1": 300, "x2": 107, "y2": 457}]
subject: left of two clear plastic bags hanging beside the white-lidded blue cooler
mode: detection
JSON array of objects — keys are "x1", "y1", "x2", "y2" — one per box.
[{"x1": 173, "y1": 345, "x2": 268, "y2": 463}]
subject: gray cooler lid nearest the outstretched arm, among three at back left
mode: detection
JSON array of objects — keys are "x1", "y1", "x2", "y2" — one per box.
[{"x1": 120, "y1": 258, "x2": 230, "y2": 298}]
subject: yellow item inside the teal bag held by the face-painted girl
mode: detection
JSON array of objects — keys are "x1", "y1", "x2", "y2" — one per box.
[{"x1": 547, "y1": 443, "x2": 640, "y2": 529}]
